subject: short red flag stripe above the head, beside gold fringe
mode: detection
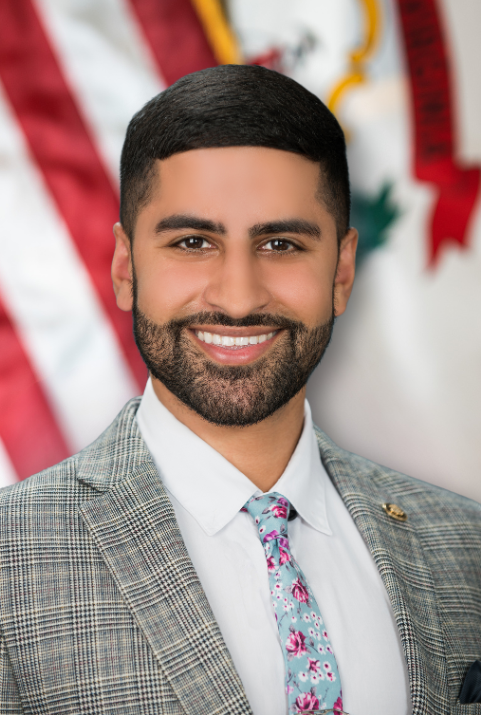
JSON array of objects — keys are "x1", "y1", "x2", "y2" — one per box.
[{"x1": 130, "y1": 0, "x2": 218, "y2": 84}]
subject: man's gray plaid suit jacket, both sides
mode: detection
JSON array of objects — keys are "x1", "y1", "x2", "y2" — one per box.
[{"x1": 0, "y1": 399, "x2": 481, "y2": 715}]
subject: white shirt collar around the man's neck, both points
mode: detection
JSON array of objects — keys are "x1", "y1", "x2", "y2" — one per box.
[{"x1": 137, "y1": 379, "x2": 332, "y2": 536}]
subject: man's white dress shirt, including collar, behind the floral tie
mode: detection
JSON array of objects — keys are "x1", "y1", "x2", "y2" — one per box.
[{"x1": 137, "y1": 380, "x2": 412, "y2": 715}]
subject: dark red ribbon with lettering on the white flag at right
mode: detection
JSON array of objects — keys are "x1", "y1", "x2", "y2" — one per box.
[{"x1": 398, "y1": 0, "x2": 480, "y2": 264}]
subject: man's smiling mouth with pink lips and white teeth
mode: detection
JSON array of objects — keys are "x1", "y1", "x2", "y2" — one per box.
[{"x1": 190, "y1": 326, "x2": 283, "y2": 365}]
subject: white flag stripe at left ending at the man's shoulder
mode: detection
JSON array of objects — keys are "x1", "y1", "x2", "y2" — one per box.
[{"x1": 0, "y1": 84, "x2": 137, "y2": 450}]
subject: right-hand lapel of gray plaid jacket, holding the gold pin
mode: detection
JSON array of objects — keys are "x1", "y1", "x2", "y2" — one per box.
[{"x1": 316, "y1": 430, "x2": 450, "y2": 715}]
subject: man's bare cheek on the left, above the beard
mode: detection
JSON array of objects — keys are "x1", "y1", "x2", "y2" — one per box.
[{"x1": 136, "y1": 261, "x2": 207, "y2": 323}]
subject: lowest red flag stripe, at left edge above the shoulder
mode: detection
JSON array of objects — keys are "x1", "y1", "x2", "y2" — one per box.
[{"x1": 0, "y1": 290, "x2": 69, "y2": 479}]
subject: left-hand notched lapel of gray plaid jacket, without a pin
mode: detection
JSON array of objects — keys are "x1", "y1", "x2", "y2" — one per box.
[{"x1": 79, "y1": 403, "x2": 252, "y2": 715}]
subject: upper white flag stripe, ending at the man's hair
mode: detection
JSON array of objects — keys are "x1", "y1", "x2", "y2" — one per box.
[{"x1": 36, "y1": 0, "x2": 165, "y2": 184}]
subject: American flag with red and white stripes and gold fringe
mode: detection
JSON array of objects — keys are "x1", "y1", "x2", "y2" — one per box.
[{"x1": 0, "y1": 0, "x2": 237, "y2": 486}]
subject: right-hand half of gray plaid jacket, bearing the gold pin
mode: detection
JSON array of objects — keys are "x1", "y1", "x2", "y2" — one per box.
[{"x1": 316, "y1": 428, "x2": 481, "y2": 715}]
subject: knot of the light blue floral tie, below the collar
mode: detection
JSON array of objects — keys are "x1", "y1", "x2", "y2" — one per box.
[{"x1": 244, "y1": 492, "x2": 291, "y2": 549}]
